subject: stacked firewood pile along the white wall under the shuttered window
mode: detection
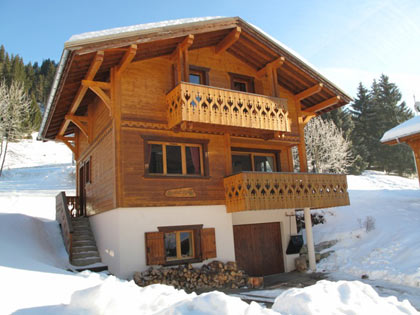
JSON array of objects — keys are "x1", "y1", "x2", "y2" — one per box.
[{"x1": 134, "y1": 261, "x2": 249, "y2": 291}]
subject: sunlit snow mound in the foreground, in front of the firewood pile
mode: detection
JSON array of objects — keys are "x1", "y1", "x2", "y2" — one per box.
[{"x1": 67, "y1": 276, "x2": 276, "y2": 315}]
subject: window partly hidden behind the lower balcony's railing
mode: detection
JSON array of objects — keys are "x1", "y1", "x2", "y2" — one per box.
[{"x1": 232, "y1": 152, "x2": 277, "y2": 173}]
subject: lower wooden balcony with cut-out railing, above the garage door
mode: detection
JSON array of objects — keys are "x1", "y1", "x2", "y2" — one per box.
[{"x1": 224, "y1": 172, "x2": 350, "y2": 212}]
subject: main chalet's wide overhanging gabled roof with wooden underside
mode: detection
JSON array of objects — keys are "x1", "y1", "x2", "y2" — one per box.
[{"x1": 40, "y1": 17, "x2": 351, "y2": 139}]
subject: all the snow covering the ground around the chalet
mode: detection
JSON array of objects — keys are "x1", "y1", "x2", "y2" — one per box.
[{"x1": 0, "y1": 136, "x2": 420, "y2": 314}]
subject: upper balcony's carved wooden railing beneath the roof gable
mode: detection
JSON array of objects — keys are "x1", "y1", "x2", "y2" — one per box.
[{"x1": 166, "y1": 83, "x2": 290, "y2": 132}]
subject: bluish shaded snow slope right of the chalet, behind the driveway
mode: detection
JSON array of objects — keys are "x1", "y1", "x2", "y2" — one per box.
[{"x1": 313, "y1": 172, "x2": 420, "y2": 288}]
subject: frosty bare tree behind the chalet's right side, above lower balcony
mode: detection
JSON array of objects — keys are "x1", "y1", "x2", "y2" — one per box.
[{"x1": 293, "y1": 117, "x2": 354, "y2": 173}]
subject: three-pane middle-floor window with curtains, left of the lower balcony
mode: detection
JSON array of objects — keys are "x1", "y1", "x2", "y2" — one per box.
[{"x1": 145, "y1": 141, "x2": 204, "y2": 176}]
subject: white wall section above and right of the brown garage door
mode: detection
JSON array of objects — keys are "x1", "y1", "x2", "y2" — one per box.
[{"x1": 232, "y1": 209, "x2": 299, "y2": 272}]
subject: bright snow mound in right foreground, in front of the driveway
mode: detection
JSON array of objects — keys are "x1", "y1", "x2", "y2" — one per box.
[{"x1": 273, "y1": 280, "x2": 418, "y2": 315}]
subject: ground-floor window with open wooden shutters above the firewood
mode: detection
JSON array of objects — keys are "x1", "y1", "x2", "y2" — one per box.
[{"x1": 145, "y1": 224, "x2": 217, "y2": 265}]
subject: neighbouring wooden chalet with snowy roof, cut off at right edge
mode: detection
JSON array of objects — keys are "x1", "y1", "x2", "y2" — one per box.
[{"x1": 381, "y1": 115, "x2": 420, "y2": 183}]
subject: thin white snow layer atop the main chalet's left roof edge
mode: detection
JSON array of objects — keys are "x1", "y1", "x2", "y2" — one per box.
[{"x1": 66, "y1": 16, "x2": 223, "y2": 44}]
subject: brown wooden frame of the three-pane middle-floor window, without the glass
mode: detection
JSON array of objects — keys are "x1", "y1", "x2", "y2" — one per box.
[{"x1": 142, "y1": 136, "x2": 209, "y2": 179}]
